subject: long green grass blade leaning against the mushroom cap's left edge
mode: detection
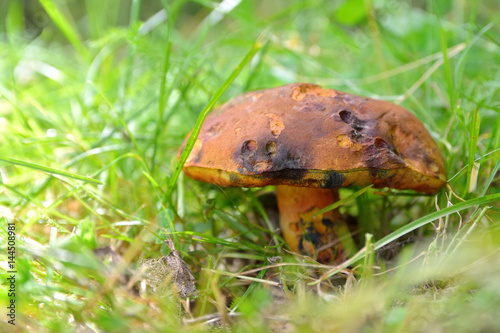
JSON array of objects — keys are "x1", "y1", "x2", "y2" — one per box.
[{"x1": 163, "y1": 32, "x2": 265, "y2": 205}]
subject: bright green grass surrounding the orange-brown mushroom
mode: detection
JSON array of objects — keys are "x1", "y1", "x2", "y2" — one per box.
[{"x1": 0, "y1": 0, "x2": 500, "y2": 332}]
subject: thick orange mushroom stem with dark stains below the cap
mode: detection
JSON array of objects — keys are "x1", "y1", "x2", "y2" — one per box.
[{"x1": 276, "y1": 185, "x2": 345, "y2": 263}]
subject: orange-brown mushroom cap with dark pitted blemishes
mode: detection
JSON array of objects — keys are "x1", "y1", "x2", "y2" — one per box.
[{"x1": 180, "y1": 83, "x2": 446, "y2": 193}]
